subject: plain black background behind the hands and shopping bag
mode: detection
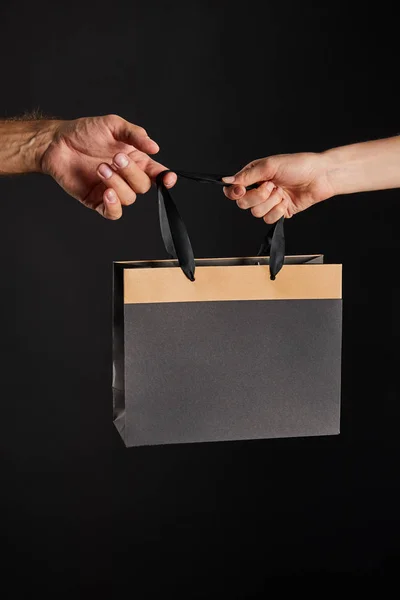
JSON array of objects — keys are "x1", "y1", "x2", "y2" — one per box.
[{"x1": 0, "y1": 0, "x2": 400, "y2": 598}]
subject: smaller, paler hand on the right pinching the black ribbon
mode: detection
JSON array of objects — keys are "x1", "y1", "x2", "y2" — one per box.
[{"x1": 223, "y1": 153, "x2": 334, "y2": 223}]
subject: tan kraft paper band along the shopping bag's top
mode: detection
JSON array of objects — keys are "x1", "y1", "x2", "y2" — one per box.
[{"x1": 124, "y1": 264, "x2": 342, "y2": 304}]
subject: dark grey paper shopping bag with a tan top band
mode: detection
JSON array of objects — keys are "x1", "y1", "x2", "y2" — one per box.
[{"x1": 113, "y1": 169, "x2": 342, "y2": 446}]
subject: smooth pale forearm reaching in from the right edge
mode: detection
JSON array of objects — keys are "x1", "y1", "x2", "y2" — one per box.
[{"x1": 324, "y1": 137, "x2": 400, "y2": 195}]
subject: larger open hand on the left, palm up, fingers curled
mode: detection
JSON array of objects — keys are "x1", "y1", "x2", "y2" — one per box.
[{"x1": 38, "y1": 115, "x2": 176, "y2": 219}]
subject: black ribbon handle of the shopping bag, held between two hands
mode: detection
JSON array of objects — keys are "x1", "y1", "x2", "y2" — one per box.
[{"x1": 156, "y1": 169, "x2": 285, "y2": 281}]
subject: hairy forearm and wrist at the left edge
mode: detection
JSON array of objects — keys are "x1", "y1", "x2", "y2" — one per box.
[{"x1": 0, "y1": 120, "x2": 58, "y2": 175}]
